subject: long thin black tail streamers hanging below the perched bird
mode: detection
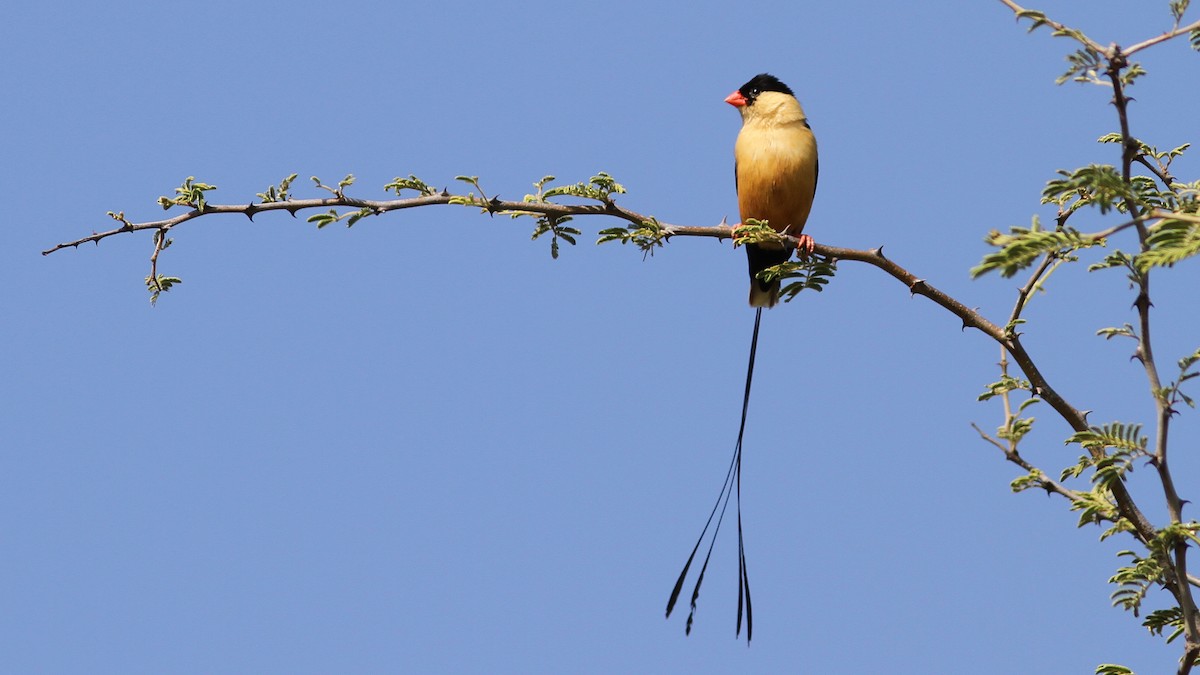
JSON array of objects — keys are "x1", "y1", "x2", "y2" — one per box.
[{"x1": 667, "y1": 307, "x2": 762, "y2": 645}]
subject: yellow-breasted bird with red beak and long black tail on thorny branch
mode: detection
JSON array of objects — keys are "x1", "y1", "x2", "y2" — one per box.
[{"x1": 666, "y1": 73, "x2": 818, "y2": 645}]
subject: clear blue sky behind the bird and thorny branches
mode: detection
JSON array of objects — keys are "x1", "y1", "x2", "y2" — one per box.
[{"x1": 0, "y1": 0, "x2": 1200, "y2": 674}]
